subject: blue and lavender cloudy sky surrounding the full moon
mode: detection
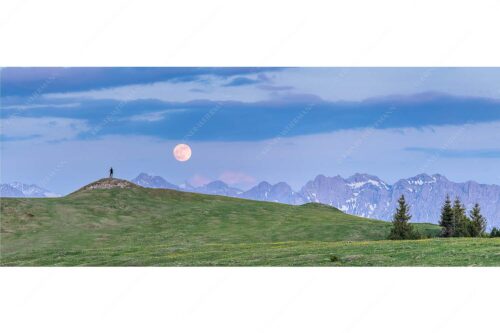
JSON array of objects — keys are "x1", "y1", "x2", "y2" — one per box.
[{"x1": 0, "y1": 67, "x2": 500, "y2": 194}]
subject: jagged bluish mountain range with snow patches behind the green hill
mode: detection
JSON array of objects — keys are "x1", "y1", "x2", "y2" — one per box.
[{"x1": 0, "y1": 173, "x2": 500, "y2": 227}]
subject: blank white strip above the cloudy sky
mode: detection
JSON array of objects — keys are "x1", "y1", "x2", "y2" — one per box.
[{"x1": 0, "y1": 0, "x2": 500, "y2": 66}]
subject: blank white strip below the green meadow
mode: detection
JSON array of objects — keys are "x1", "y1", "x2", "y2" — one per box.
[{"x1": 0, "y1": 268, "x2": 500, "y2": 333}]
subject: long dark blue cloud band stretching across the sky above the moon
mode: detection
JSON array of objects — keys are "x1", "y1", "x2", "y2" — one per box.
[{"x1": 2, "y1": 92, "x2": 500, "y2": 141}]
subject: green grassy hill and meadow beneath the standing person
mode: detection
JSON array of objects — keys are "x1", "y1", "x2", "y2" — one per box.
[{"x1": 0, "y1": 182, "x2": 500, "y2": 266}]
